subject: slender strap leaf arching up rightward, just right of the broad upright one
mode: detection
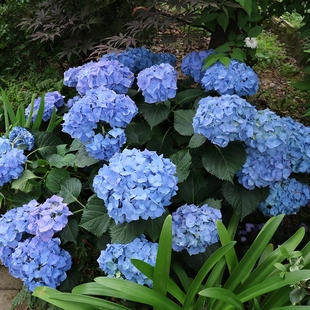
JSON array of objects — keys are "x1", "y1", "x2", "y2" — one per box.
[{"x1": 182, "y1": 242, "x2": 236, "y2": 310}]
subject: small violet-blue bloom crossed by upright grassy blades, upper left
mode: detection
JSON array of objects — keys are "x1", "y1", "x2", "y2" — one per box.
[{"x1": 25, "y1": 91, "x2": 64, "y2": 122}]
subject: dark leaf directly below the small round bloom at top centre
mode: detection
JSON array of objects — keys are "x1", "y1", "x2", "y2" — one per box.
[{"x1": 138, "y1": 103, "x2": 170, "y2": 129}]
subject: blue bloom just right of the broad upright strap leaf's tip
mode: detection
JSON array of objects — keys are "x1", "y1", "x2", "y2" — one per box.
[{"x1": 172, "y1": 204, "x2": 222, "y2": 255}]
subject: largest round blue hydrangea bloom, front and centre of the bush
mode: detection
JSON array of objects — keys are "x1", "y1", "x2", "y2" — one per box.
[{"x1": 93, "y1": 149, "x2": 178, "y2": 223}]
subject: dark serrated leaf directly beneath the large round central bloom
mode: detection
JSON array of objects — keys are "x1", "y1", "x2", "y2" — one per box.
[{"x1": 110, "y1": 220, "x2": 147, "y2": 244}]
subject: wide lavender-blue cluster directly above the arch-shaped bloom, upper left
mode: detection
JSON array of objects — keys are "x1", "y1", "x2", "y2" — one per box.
[{"x1": 64, "y1": 60, "x2": 134, "y2": 95}]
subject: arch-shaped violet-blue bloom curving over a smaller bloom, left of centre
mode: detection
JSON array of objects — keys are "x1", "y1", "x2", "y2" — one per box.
[{"x1": 62, "y1": 87, "x2": 138, "y2": 143}]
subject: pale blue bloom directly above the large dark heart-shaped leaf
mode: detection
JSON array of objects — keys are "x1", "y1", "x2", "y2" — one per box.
[{"x1": 193, "y1": 95, "x2": 257, "y2": 147}]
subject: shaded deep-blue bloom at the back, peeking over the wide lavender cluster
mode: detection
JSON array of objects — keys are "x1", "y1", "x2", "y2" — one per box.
[{"x1": 100, "y1": 47, "x2": 154, "y2": 73}]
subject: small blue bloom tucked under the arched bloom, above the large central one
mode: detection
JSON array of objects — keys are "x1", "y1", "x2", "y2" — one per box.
[{"x1": 85, "y1": 128, "x2": 126, "y2": 161}]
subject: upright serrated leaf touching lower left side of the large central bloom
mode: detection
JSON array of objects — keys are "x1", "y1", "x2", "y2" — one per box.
[{"x1": 80, "y1": 196, "x2": 112, "y2": 237}]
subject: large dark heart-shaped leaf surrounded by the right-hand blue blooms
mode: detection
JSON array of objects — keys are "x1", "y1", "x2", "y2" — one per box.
[{"x1": 202, "y1": 143, "x2": 246, "y2": 183}]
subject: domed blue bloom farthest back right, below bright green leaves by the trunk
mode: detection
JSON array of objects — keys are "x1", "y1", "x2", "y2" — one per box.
[{"x1": 200, "y1": 59, "x2": 259, "y2": 97}]
